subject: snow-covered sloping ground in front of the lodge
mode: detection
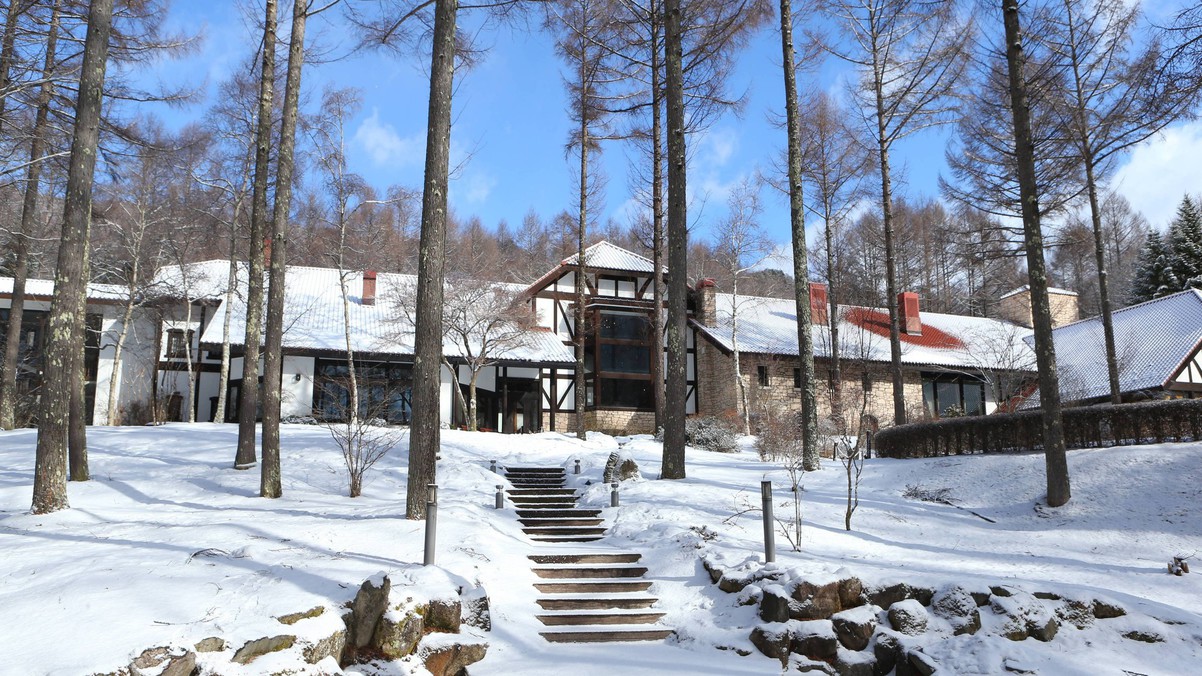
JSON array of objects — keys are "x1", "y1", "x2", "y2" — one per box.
[{"x1": 0, "y1": 423, "x2": 1202, "y2": 675}]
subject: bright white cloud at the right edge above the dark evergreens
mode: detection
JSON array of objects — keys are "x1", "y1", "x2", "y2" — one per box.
[{"x1": 1111, "y1": 121, "x2": 1202, "y2": 229}]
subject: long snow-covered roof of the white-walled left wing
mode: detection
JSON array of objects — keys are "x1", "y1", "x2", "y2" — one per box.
[{"x1": 201, "y1": 266, "x2": 575, "y2": 363}]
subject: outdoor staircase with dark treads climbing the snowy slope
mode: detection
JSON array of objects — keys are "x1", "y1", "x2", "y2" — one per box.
[{"x1": 505, "y1": 467, "x2": 672, "y2": 644}]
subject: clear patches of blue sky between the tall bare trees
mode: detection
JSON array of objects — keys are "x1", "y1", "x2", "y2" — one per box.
[{"x1": 155, "y1": 0, "x2": 1202, "y2": 255}]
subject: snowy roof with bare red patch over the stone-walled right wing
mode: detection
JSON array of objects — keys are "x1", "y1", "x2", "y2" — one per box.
[{"x1": 695, "y1": 293, "x2": 1035, "y2": 370}]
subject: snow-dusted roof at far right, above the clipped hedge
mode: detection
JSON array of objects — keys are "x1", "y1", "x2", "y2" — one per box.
[{"x1": 1031, "y1": 289, "x2": 1202, "y2": 403}]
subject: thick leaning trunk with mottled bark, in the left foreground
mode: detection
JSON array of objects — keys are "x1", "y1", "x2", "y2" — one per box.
[{"x1": 32, "y1": 0, "x2": 113, "y2": 514}]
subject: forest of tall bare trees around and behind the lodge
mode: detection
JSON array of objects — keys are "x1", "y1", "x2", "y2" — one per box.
[{"x1": 0, "y1": 0, "x2": 1202, "y2": 510}]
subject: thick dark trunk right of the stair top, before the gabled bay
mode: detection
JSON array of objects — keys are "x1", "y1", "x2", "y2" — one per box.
[{"x1": 660, "y1": 0, "x2": 689, "y2": 479}]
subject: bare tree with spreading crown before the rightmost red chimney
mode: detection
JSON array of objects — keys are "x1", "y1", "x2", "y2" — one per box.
[{"x1": 819, "y1": 0, "x2": 971, "y2": 423}]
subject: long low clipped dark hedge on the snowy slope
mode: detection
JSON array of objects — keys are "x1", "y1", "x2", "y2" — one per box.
[{"x1": 874, "y1": 399, "x2": 1202, "y2": 458}]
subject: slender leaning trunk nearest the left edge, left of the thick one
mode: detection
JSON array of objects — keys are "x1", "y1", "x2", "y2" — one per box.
[{"x1": 0, "y1": 0, "x2": 61, "y2": 429}]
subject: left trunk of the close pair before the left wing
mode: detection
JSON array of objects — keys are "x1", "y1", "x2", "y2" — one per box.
[{"x1": 233, "y1": 0, "x2": 276, "y2": 469}]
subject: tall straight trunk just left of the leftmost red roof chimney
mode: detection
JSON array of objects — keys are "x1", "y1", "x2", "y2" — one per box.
[{"x1": 780, "y1": 0, "x2": 821, "y2": 472}]
